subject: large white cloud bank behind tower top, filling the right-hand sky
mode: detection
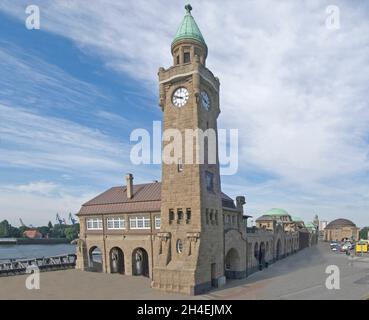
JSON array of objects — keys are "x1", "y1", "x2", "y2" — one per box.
[{"x1": 0, "y1": 0, "x2": 369, "y2": 223}]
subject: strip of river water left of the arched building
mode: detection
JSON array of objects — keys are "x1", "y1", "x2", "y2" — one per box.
[{"x1": 0, "y1": 244, "x2": 76, "y2": 262}]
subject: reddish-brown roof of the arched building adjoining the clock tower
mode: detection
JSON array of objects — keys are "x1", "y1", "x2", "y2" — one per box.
[{"x1": 78, "y1": 182, "x2": 235, "y2": 215}]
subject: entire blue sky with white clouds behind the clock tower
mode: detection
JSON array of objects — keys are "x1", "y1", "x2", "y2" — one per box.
[{"x1": 0, "y1": 0, "x2": 369, "y2": 226}]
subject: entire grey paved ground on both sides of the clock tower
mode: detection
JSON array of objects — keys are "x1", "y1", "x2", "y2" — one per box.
[{"x1": 0, "y1": 244, "x2": 369, "y2": 300}]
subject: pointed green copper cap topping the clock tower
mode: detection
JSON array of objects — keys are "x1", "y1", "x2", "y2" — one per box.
[{"x1": 172, "y1": 4, "x2": 206, "y2": 46}]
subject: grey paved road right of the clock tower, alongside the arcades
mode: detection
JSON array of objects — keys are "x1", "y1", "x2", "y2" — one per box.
[{"x1": 206, "y1": 243, "x2": 369, "y2": 300}]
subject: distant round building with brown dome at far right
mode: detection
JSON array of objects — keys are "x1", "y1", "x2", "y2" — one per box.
[{"x1": 324, "y1": 219, "x2": 360, "y2": 241}]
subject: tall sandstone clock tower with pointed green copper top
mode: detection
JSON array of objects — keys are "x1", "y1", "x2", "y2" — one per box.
[{"x1": 152, "y1": 5, "x2": 225, "y2": 295}]
